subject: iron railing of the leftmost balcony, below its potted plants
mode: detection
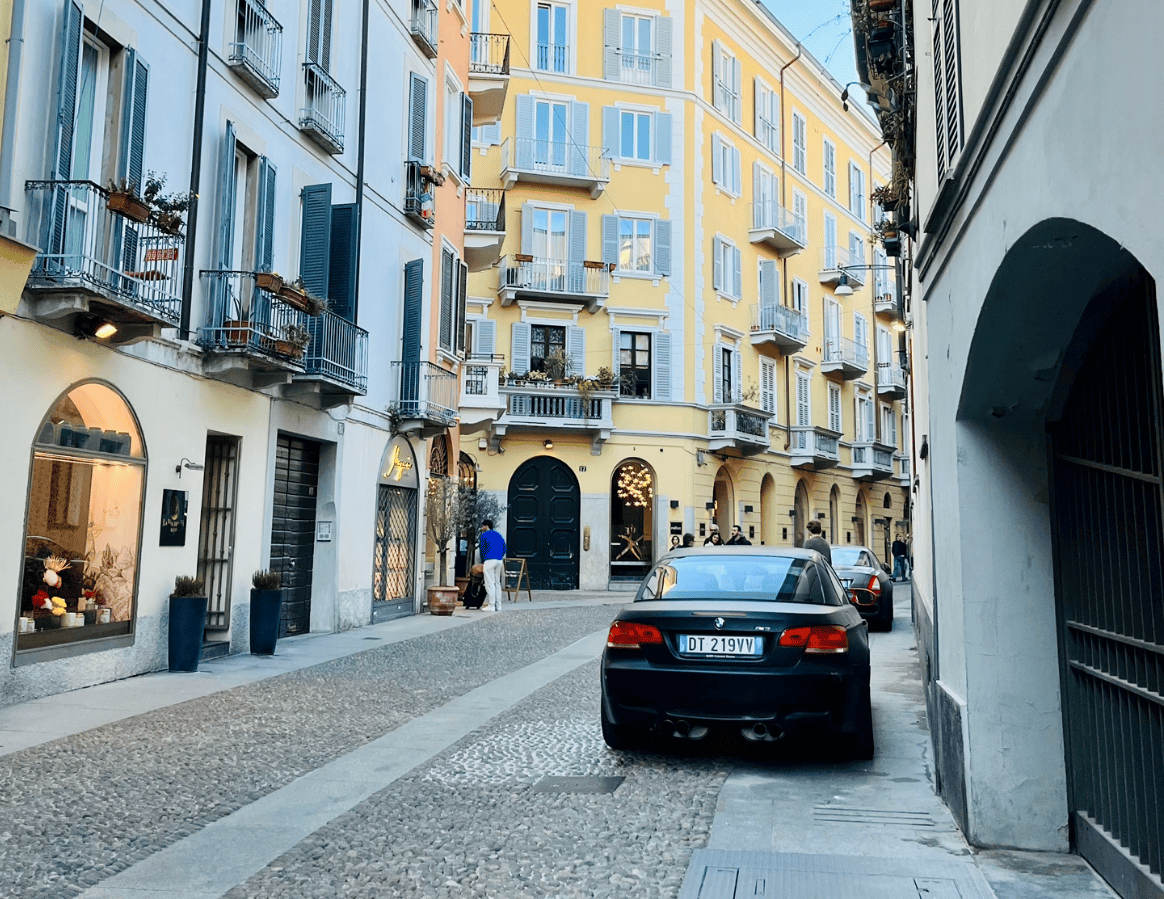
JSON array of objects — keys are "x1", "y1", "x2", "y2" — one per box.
[{"x1": 24, "y1": 180, "x2": 185, "y2": 326}]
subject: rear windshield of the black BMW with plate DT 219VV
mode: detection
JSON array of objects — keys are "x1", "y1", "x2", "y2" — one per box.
[{"x1": 636, "y1": 555, "x2": 840, "y2": 606}]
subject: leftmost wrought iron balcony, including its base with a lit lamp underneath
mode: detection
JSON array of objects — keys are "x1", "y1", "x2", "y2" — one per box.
[{"x1": 24, "y1": 180, "x2": 185, "y2": 345}]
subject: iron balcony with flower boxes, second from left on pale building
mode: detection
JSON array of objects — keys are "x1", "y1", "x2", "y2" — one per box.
[{"x1": 198, "y1": 270, "x2": 310, "y2": 390}]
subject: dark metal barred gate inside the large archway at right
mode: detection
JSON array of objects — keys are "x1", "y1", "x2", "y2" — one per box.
[{"x1": 1051, "y1": 279, "x2": 1164, "y2": 897}]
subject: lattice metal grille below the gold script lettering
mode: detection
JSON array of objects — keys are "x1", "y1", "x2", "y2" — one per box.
[{"x1": 371, "y1": 484, "x2": 417, "y2": 621}]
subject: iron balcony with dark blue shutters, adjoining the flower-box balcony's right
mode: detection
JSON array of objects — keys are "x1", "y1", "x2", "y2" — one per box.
[{"x1": 283, "y1": 312, "x2": 368, "y2": 409}]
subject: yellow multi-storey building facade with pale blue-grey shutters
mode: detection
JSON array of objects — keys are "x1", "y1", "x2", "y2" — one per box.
[{"x1": 459, "y1": 0, "x2": 909, "y2": 589}]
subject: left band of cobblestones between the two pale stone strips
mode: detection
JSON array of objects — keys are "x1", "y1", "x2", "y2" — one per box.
[{"x1": 0, "y1": 606, "x2": 628, "y2": 899}]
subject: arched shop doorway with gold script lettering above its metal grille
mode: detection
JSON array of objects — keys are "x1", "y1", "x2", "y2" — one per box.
[{"x1": 371, "y1": 437, "x2": 420, "y2": 623}]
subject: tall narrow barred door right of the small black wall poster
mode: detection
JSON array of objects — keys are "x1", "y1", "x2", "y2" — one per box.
[{"x1": 198, "y1": 437, "x2": 239, "y2": 630}]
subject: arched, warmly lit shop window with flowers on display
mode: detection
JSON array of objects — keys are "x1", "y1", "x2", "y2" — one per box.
[{"x1": 16, "y1": 383, "x2": 146, "y2": 650}]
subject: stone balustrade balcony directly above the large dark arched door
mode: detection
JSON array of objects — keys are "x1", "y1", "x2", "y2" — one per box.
[{"x1": 492, "y1": 383, "x2": 617, "y2": 454}]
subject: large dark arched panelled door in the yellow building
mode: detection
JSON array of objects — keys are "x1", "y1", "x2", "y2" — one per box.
[{"x1": 504, "y1": 455, "x2": 582, "y2": 590}]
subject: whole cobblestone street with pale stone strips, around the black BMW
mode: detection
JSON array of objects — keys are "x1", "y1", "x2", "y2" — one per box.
[{"x1": 0, "y1": 587, "x2": 1108, "y2": 899}]
